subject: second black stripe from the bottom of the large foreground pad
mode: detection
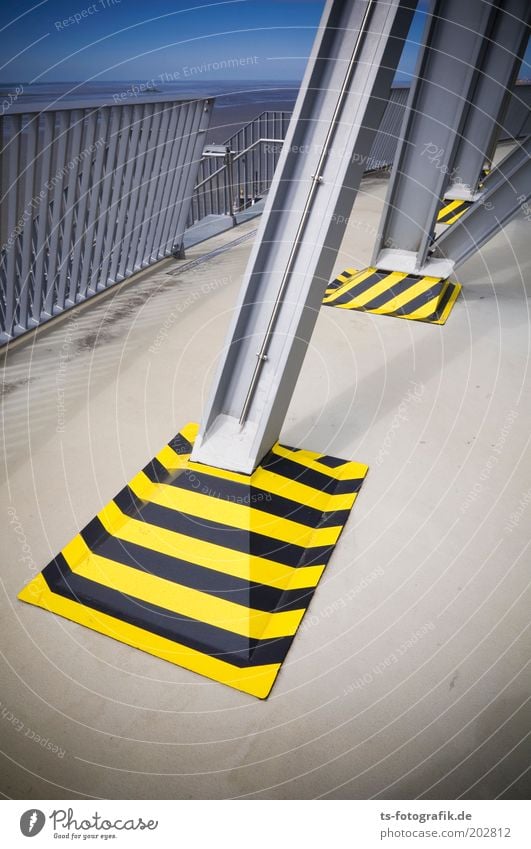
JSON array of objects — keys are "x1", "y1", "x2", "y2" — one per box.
[{"x1": 81, "y1": 519, "x2": 314, "y2": 613}]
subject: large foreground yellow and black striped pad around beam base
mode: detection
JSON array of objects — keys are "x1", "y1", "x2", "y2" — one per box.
[{"x1": 19, "y1": 424, "x2": 367, "y2": 698}]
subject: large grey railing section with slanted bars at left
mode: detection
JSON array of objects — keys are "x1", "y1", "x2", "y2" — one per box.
[{"x1": 0, "y1": 97, "x2": 211, "y2": 344}]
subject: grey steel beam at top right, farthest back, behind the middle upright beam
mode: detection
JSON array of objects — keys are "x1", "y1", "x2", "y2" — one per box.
[{"x1": 445, "y1": 0, "x2": 531, "y2": 200}]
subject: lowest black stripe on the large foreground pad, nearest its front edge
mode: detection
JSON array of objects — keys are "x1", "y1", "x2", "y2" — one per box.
[{"x1": 42, "y1": 555, "x2": 293, "y2": 668}]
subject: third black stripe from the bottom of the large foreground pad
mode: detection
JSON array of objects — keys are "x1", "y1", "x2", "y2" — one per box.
[{"x1": 114, "y1": 486, "x2": 330, "y2": 568}]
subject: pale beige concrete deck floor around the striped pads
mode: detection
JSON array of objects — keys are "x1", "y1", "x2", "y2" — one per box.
[{"x1": 0, "y1": 167, "x2": 531, "y2": 799}]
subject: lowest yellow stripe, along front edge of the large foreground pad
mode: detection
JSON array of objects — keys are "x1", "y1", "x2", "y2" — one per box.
[{"x1": 19, "y1": 575, "x2": 280, "y2": 699}]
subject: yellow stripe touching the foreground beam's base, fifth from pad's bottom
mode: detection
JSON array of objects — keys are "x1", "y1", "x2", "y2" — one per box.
[{"x1": 157, "y1": 445, "x2": 360, "y2": 513}]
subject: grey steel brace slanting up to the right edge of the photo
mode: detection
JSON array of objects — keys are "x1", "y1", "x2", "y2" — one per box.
[{"x1": 433, "y1": 136, "x2": 531, "y2": 268}]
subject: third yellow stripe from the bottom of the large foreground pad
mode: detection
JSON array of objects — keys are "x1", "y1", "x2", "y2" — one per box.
[{"x1": 98, "y1": 501, "x2": 324, "y2": 590}]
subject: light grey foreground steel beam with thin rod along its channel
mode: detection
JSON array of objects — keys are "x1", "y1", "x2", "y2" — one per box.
[{"x1": 192, "y1": 0, "x2": 416, "y2": 474}]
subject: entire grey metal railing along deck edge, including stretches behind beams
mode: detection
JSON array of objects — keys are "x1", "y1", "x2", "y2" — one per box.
[{"x1": 0, "y1": 83, "x2": 531, "y2": 345}]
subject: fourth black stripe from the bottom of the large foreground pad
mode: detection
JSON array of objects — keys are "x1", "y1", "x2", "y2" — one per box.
[{"x1": 144, "y1": 460, "x2": 354, "y2": 528}]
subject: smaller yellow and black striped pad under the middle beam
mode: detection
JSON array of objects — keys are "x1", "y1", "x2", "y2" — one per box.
[{"x1": 323, "y1": 268, "x2": 461, "y2": 324}]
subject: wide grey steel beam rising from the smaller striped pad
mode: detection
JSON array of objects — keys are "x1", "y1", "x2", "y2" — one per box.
[{"x1": 372, "y1": 0, "x2": 499, "y2": 277}]
